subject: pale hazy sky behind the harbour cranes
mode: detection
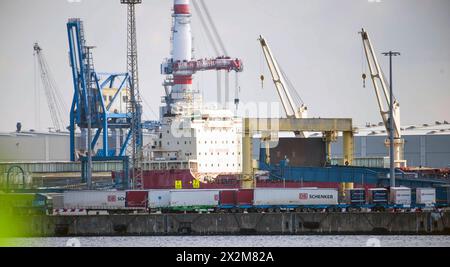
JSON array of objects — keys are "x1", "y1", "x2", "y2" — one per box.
[{"x1": 0, "y1": 0, "x2": 450, "y2": 131}]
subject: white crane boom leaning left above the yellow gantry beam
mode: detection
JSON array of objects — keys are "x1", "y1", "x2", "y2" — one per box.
[{"x1": 258, "y1": 35, "x2": 307, "y2": 119}]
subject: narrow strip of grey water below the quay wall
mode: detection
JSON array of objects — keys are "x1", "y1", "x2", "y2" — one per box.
[{"x1": 5, "y1": 235, "x2": 450, "y2": 247}]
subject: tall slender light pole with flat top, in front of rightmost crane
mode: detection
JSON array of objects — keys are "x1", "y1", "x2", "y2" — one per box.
[{"x1": 383, "y1": 51, "x2": 400, "y2": 187}]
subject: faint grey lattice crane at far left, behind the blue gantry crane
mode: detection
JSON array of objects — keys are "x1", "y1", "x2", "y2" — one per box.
[{"x1": 33, "y1": 43, "x2": 68, "y2": 132}]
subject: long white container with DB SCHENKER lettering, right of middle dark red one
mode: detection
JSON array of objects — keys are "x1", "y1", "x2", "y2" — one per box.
[{"x1": 253, "y1": 188, "x2": 338, "y2": 206}]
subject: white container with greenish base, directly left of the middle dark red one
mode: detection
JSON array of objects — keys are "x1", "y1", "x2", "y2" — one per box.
[{"x1": 170, "y1": 189, "x2": 219, "y2": 207}]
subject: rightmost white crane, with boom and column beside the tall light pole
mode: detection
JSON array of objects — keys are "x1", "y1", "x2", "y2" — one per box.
[{"x1": 360, "y1": 29, "x2": 406, "y2": 167}]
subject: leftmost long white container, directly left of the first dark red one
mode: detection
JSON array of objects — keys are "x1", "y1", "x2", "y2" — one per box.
[{"x1": 64, "y1": 190, "x2": 126, "y2": 210}]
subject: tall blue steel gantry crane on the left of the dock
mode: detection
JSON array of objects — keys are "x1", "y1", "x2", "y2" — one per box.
[{"x1": 67, "y1": 18, "x2": 142, "y2": 188}]
